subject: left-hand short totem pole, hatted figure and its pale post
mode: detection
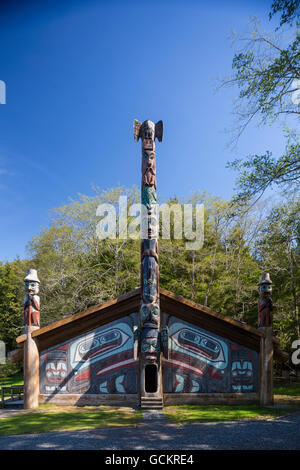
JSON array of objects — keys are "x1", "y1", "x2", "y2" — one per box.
[{"x1": 24, "y1": 269, "x2": 40, "y2": 409}]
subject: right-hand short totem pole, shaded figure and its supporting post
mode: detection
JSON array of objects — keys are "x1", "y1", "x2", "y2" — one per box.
[{"x1": 258, "y1": 272, "x2": 273, "y2": 405}]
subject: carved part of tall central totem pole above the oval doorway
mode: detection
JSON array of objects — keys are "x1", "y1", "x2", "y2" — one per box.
[{"x1": 133, "y1": 120, "x2": 163, "y2": 363}]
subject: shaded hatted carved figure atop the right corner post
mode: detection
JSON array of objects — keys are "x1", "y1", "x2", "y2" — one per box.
[{"x1": 258, "y1": 272, "x2": 273, "y2": 327}]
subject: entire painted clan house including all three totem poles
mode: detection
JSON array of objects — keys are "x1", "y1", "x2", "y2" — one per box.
[{"x1": 15, "y1": 120, "x2": 286, "y2": 409}]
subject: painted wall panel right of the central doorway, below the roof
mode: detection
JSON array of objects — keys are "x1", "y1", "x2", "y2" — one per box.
[{"x1": 163, "y1": 314, "x2": 259, "y2": 394}]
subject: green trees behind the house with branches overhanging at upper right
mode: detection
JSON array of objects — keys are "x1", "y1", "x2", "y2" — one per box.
[{"x1": 0, "y1": 0, "x2": 300, "y2": 364}]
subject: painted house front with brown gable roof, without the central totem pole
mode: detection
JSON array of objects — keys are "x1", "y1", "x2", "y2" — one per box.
[{"x1": 17, "y1": 289, "x2": 285, "y2": 406}]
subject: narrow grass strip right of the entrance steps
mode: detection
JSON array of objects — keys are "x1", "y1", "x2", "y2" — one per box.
[{"x1": 164, "y1": 405, "x2": 295, "y2": 424}]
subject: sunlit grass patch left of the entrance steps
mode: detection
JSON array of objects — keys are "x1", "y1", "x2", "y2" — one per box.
[{"x1": 0, "y1": 405, "x2": 142, "y2": 436}]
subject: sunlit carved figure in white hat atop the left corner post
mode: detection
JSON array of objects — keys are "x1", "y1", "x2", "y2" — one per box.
[{"x1": 24, "y1": 269, "x2": 40, "y2": 328}]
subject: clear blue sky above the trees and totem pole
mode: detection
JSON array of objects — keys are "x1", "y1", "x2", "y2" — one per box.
[{"x1": 0, "y1": 0, "x2": 290, "y2": 261}]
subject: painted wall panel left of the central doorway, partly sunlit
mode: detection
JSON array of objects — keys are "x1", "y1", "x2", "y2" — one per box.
[{"x1": 40, "y1": 314, "x2": 138, "y2": 395}]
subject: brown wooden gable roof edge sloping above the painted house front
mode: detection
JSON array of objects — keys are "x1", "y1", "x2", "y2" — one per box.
[{"x1": 16, "y1": 288, "x2": 288, "y2": 361}]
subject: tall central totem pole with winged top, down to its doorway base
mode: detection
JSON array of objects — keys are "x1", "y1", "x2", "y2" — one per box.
[{"x1": 133, "y1": 120, "x2": 163, "y2": 408}]
